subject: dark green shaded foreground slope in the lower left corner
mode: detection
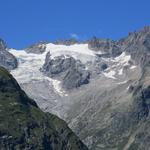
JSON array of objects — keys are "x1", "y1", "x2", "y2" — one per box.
[{"x1": 0, "y1": 67, "x2": 87, "y2": 150}]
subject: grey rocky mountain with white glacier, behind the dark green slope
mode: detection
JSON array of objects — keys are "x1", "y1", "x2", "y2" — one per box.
[{"x1": 0, "y1": 26, "x2": 150, "y2": 150}]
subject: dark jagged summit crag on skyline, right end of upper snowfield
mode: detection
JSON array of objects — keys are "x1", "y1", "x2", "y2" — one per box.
[{"x1": 88, "y1": 37, "x2": 122, "y2": 57}]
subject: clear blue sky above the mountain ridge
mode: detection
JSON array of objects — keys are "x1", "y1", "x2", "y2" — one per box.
[{"x1": 0, "y1": 0, "x2": 150, "y2": 49}]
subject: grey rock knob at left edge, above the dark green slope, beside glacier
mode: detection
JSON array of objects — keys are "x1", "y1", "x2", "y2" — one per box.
[{"x1": 0, "y1": 39, "x2": 18, "y2": 70}]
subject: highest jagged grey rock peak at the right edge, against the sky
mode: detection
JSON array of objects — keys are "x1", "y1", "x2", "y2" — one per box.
[{"x1": 119, "y1": 27, "x2": 150, "y2": 68}]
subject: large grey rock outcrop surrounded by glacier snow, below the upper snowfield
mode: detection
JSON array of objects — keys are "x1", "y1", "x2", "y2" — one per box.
[{"x1": 41, "y1": 53, "x2": 90, "y2": 89}]
